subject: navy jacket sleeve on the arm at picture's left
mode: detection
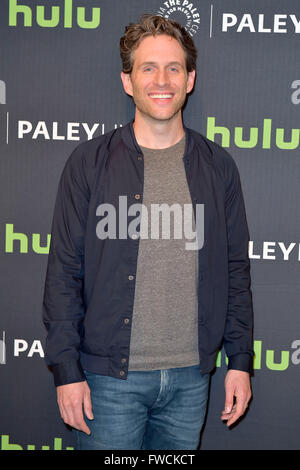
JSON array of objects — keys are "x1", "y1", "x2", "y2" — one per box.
[{"x1": 43, "y1": 145, "x2": 89, "y2": 386}]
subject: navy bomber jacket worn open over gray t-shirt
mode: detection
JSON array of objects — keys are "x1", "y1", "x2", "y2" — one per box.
[{"x1": 43, "y1": 122, "x2": 254, "y2": 386}]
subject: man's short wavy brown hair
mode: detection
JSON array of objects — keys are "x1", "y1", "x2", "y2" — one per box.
[{"x1": 120, "y1": 14, "x2": 197, "y2": 73}]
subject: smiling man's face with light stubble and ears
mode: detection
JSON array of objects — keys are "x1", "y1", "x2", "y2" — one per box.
[{"x1": 121, "y1": 35, "x2": 195, "y2": 121}]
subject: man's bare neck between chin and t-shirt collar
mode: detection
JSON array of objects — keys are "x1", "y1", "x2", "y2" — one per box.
[{"x1": 133, "y1": 110, "x2": 184, "y2": 149}]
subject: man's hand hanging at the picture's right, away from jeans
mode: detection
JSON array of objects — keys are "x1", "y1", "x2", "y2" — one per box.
[{"x1": 221, "y1": 369, "x2": 252, "y2": 427}]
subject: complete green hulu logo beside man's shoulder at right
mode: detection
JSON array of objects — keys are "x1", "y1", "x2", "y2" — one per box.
[{"x1": 206, "y1": 117, "x2": 300, "y2": 150}]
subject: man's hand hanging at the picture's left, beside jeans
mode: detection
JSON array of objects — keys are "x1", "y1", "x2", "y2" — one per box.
[{"x1": 57, "y1": 381, "x2": 94, "y2": 434}]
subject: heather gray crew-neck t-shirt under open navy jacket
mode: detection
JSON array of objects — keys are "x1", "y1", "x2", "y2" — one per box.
[{"x1": 129, "y1": 137, "x2": 199, "y2": 370}]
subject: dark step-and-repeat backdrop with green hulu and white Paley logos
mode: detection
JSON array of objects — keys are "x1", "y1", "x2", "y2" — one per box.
[{"x1": 0, "y1": 0, "x2": 300, "y2": 450}]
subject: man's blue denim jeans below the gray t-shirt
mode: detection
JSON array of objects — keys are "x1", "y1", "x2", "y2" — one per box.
[{"x1": 74, "y1": 365, "x2": 210, "y2": 450}]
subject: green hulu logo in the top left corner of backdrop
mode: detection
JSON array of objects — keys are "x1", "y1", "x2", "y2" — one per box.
[{"x1": 9, "y1": 0, "x2": 100, "y2": 29}]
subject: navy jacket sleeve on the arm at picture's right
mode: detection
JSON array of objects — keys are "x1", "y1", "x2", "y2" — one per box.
[{"x1": 224, "y1": 159, "x2": 254, "y2": 373}]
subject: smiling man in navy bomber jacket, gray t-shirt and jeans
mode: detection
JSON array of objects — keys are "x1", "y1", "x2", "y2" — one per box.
[{"x1": 44, "y1": 15, "x2": 253, "y2": 449}]
